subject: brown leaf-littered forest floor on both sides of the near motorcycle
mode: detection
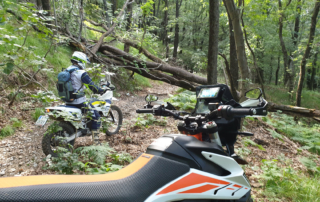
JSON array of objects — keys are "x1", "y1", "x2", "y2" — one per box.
[{"x1": 0, "y1": 82, "x2": 320, "y2": 201}]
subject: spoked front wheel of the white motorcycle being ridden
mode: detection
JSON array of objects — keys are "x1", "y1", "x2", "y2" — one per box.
[{"x1": 102, "y1": 105, "x2": 123, "y2": 136}]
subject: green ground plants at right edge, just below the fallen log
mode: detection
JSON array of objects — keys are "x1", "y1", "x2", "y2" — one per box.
[{"x1": 263, "y1": 111, "x2": 320, "y2": 153}]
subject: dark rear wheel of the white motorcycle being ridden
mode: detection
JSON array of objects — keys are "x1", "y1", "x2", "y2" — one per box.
[{"x1": 42, "y1": 122, "x2": 75, "y2": 157}]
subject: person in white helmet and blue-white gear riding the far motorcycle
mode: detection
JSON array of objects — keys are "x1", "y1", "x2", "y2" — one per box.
[{"x1": 66, "y1": 51, "x2": 105, "y2": 145}]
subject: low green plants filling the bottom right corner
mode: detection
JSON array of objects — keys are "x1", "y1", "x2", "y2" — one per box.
[{"x1": 258, "y1": 160, "x2": 320, "y2": 202}]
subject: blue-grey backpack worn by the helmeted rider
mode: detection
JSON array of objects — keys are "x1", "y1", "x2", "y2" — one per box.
[{"x1": 57, "y1": 67, "x2": 84, "y2": 102}]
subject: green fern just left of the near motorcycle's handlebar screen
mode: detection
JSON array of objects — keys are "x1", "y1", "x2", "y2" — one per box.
[{"x1": 165, "y1": 90, "x2": 197, "y2": 110}]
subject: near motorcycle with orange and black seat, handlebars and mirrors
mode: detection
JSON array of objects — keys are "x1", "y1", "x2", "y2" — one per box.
[{"x1": 0, "y1": 84, "x2": 268, "y2": 202}]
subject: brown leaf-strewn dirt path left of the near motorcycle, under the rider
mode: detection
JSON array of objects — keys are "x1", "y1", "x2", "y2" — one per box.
[{"x1": 0, "y1": 82, "x2": 177, "y2": 177}]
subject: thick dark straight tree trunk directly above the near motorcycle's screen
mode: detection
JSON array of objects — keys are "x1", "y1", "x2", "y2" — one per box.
[{"x1": 207, "y1": 1, "x2": 219, "y2": 84}]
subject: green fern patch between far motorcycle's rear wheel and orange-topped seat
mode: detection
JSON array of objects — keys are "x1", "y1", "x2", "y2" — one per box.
[{"x1": 43, "y1": 143, "x2": 132, "y2": 174}]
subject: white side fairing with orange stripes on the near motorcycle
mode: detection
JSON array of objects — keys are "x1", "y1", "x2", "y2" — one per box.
[{"x1": 145, "y1": 152, "x2": 251, "y2": 202}]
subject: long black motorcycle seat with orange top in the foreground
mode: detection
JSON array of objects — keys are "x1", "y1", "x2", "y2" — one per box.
[{"x1": 0, "y1": 154, "x2": 190, "y2": 202}]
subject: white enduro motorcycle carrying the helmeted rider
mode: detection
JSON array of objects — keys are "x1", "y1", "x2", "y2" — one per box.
[{"x1": 36, "y1": 80, "x2": 123, "y2": 157}]
